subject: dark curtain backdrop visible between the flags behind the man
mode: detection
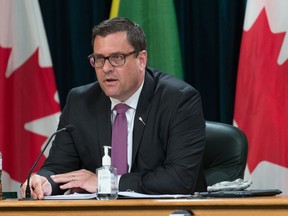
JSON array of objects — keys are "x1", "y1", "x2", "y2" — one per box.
[{"x1": 39, "y1": 0, "x2": 246, "y2": 124}]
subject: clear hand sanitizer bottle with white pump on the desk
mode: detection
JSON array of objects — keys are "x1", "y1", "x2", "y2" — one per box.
[{"x1": 96, "y1": 146, "x2": 118, "y2": 200}]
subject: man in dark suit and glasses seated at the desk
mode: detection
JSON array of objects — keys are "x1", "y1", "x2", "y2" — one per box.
[{"x1": 21, "y1": 18, "x2": 206, "y2": 199}]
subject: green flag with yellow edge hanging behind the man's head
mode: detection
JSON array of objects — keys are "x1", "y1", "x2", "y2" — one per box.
[{"x1": 110, "y1": 0, "x2": 183, "y2": 79}]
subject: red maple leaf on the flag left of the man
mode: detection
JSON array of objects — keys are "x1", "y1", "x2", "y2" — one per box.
[{"x1": 0, "y1": 46, "x2": 60, "y2": 182}]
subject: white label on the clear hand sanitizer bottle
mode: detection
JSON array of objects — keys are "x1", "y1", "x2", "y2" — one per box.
[{"x1": 98, "y1": 169, "x2": 112, "y2": 194}]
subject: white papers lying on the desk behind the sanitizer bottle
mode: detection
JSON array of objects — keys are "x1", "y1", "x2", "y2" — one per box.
[{"x1": 44, "y1": 191, "x2": 192, "y2": 200}]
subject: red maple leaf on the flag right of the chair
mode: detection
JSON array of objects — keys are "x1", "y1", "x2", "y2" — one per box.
[{"x1": 235, "y1": 9, "x2": 288, "y2": 173}]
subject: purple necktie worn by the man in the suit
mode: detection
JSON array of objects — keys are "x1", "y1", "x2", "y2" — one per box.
[{"x1": 111, "y1": 103, "x2": 129, "y2": 175}]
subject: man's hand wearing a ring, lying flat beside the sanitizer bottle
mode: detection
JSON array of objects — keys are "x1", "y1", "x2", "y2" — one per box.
[{"x1": 51, "y1": 169, "x2": 97, "y2": 193}]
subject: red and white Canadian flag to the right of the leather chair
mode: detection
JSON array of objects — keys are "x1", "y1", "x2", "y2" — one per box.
[{"x1": 234, "y1": 0, "x2": 288, "y2": 195}]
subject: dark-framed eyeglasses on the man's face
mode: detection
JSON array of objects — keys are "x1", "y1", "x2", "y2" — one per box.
[{"x1": 88, "y1": 50, "x2": 139, "y2": 68}]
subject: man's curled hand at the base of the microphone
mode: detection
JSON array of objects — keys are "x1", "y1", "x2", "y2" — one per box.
[{"x1": 20, "y1": 174, "x2": 52, "y2": 199}]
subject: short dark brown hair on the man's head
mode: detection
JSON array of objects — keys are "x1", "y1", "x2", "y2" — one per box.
[{"x1": 92, "y1": 17, "x2": 146, "y2": 51}]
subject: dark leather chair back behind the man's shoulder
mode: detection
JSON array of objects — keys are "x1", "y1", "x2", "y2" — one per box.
[{"x1": 203, "y1": 121, "x2": 248, "y2": 186}]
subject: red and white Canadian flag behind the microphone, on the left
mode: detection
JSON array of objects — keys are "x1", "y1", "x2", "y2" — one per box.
[{"x1": 0, "y1": 0, "x2": 60, "y2": 195}]
